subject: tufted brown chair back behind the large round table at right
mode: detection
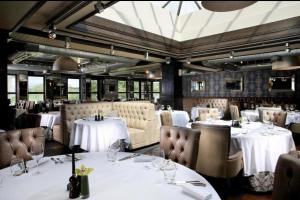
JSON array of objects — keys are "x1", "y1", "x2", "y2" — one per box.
[{"x1": 263, "y1": 110, "x2": 287, "y2": 127}]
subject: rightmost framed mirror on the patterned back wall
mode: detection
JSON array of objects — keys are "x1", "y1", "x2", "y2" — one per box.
[{"x1": 269, "y1": 76, "x2": 295, "y2": 91}]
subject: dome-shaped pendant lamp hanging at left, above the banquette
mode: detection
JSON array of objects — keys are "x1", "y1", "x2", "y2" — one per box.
[{"x1": 52, "y1": 56, "x2": 78, "y2": 73}]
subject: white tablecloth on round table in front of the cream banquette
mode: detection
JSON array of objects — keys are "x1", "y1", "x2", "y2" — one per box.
[{"x1": 70, "y1": 118, "x2": 130, "y2": 152}]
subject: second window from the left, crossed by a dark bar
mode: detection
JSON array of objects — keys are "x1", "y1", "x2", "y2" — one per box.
[{"x1": 28, "y1": 76, "x2": 44, "y2": 102}]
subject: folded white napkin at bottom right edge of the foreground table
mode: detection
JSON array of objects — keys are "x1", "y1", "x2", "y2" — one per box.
[{"x1": 182, "y1": 184, "x2": 212, "y2": 200}]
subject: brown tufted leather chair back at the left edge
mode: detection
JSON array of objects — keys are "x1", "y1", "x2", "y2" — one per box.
[{"x1": 0, "y1": 127, "x2": 45, "y2": 169}]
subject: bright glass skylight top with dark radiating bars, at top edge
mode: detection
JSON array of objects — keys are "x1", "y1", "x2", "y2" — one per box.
[{"x1": 151, "y1": 1, "x2": 201, "y2": 15}]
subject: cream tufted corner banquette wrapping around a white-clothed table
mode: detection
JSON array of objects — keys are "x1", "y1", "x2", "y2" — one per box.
[{"x1": 61, "y1": 102, "x2": 159, "y2": 149}]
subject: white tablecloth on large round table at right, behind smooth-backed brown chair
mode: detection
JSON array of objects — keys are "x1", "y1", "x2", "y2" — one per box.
[{"x1": 187, "y1": 120, "x2": 296, "y2": 176}]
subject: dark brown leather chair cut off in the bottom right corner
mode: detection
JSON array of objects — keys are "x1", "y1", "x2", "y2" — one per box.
[{"x1": 272, "y1": 154, "x2": 300, "y2": 200}]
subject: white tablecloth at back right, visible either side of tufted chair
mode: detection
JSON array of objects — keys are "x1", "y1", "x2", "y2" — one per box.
[{"x1": 241, "y1": 110, "x2": 300, "y2": 125}]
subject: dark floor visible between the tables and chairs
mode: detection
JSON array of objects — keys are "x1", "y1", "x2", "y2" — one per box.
[{"x1": 45, "y1": 137, "x2": 300, "y2": 200}]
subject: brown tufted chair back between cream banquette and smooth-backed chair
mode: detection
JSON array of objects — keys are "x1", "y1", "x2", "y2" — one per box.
[{"x1": 160, "y1": 126, "x2": 200, "y2": 169}]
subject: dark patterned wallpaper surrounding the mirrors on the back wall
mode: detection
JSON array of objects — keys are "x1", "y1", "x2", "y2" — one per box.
[{"x1": 183, "y1": 69, "x2": 300, "y2": 98}]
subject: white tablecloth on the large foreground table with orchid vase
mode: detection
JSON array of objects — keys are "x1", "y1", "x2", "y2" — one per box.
[{"x1": 0, "y1": 153, "x2": 220, "y2": 200}]
